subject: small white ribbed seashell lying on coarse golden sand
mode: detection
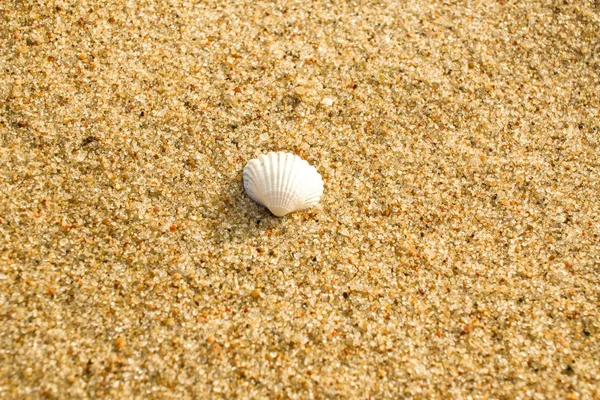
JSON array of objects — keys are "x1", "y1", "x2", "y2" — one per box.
[{"x1": 244, "y1": 152, "x2": 323, "y2": 217}]
